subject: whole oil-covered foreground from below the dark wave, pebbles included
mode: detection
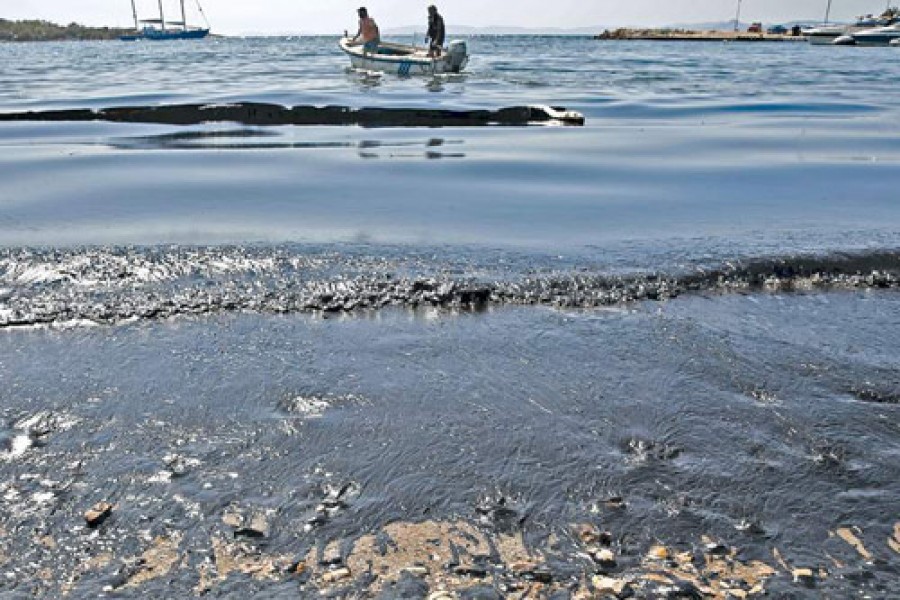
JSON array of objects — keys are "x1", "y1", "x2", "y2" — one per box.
[{"x1": 0, "y1": 298, "x2": 900, "y2": 600}]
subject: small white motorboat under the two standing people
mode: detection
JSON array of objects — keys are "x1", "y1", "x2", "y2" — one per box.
[{"x1": 339, "y1": 38, "x2": 469, "y2": 76}]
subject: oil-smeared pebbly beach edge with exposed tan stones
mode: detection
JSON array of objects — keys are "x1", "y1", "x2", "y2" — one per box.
[{"x1": 0, "y1": 390, "x2": 900, "y2": 600}]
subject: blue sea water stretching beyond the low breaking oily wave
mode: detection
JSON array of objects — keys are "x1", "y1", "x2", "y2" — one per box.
[{"x1": 0, "y1": 37, "x2": 900, "y2": 251}]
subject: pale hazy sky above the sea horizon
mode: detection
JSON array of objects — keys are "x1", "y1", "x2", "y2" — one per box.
[{"x1": 0, "y1": 0, "x2": 896, "y2": 34}]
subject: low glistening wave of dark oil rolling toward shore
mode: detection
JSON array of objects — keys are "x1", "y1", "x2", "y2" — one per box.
[{"x1": 0, "y1": 248, "x2": 900, "y2": 329}]
